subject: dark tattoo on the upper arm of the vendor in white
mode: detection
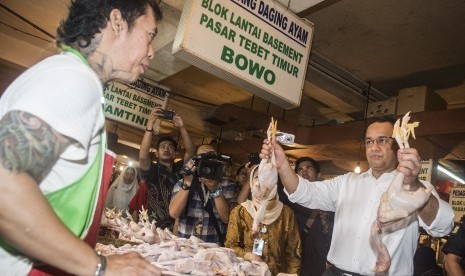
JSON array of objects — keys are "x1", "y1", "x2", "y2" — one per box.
[{"x1": 0, "y1": 111, "x2": 71, "y2": 183}]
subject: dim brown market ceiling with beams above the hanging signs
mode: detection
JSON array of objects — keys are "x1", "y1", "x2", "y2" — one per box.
[{"x1": 0, "y1": 0, "x2": 465, "y2": 174}]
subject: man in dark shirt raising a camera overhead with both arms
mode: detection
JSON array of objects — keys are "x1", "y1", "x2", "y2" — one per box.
[{"x1": 129, "y1": 108, "x2": 195, "y2": 230}]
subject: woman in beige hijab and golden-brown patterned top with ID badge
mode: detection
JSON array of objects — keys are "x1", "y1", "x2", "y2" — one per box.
[{"x1": 225, "y1": 166, "x2": 301, "y2": 275}]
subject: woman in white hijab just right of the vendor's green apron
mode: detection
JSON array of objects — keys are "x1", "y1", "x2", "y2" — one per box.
[{"x1": 105, "y1": 166, "x2": 139, "y2": 217}]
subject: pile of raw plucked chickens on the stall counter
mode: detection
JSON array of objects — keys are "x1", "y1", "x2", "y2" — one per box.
[{"x1": 99, "y1": 209, "x2": 271, "y2": 276}]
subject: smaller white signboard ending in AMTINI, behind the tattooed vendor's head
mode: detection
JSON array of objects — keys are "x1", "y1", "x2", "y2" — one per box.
[{"x1": 103, "y1": 79, "x2": 169, "y2": 129}]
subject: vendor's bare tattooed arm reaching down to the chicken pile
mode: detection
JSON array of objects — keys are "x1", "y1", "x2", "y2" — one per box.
[{"x1": 0, "y1": 111, "x2": 158, "y2": 275}]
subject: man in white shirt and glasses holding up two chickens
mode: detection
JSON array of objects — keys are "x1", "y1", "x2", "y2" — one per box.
[{"x1": 260, "y1": 115, "x2": 454, "y2": 275}]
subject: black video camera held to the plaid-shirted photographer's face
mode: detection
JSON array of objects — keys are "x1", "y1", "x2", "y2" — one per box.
[{"x1": 181, "y1": 152, "x2": 227, "y2": 181}]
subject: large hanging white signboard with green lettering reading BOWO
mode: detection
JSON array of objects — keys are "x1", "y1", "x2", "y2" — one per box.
[{"x1": 173, "y1": 0, "x2": 313, "y2": 108}]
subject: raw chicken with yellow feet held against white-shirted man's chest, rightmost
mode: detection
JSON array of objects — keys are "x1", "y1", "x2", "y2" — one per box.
[{"x1": 371, "y1": 112, "x2": 431, "y2": 273}]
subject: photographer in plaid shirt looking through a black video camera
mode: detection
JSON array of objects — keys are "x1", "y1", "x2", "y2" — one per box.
[{"x1": 169, "y1": 145, "x2": 236, "y2": 245}]
